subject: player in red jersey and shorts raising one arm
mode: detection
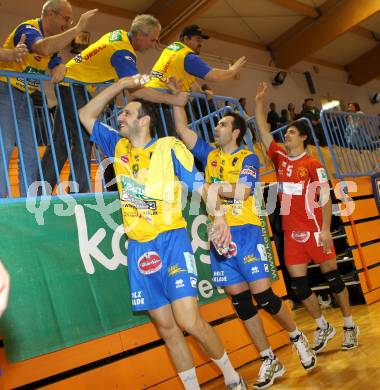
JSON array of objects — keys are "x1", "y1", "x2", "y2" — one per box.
[{"x1": 255, "y1": 83, "x2": 359, "y2": 352}]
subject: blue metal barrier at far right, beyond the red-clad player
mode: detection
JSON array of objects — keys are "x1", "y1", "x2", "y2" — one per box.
[{"x1": 321, "y1": 110, "x2": 380, "y2": 179}]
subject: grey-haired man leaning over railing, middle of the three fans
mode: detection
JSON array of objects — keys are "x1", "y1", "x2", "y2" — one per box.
[{"x1": 41, "y1": 15, "x2": 187, "y2": 197}]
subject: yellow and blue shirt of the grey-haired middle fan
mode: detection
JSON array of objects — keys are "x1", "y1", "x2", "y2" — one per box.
[{"x1": 65, "y1": 30, "x2": 138, "y2": 83}]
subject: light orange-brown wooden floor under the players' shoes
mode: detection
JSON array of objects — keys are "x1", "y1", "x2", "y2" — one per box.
[{"x1": 202, "y1": 302, "x2": 380, "y2": 390}]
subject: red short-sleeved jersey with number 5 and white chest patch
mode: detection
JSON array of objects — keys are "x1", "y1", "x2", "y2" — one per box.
[{"x1": 267, "y1": 141, "x2": 328, "y2": 232}]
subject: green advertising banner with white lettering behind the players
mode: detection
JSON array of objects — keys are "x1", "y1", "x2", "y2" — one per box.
[{"x1": 0, "y1": 194, "x2": 274, "y2": 361}]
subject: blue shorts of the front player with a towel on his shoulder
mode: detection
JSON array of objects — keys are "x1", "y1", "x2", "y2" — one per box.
[{"x1": 128, "y1": 228, "x2": 198, "y2": 311}]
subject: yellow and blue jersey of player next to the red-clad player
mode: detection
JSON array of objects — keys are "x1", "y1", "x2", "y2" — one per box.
[{"x1": 192, "y1": 137, "x2": 261, "y2": 226}]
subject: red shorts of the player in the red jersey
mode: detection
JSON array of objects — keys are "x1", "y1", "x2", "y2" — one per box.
[{"x1": 284, "y1": 230, "x2": 335, "y2": 265}]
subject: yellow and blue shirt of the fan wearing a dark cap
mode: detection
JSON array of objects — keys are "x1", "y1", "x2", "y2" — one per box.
[{"x1": 146, "y1": 42, "x2": 211, "y2": 92}]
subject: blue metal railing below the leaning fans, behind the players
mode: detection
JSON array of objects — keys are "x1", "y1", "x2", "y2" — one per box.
[{"x1": 0, "y1": 70, "x2": 330, "y2": 201}]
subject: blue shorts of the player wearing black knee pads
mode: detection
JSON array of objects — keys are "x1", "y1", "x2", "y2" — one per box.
[{"x1": 210, "y1": 225, "x2": 270, "y2": 287}]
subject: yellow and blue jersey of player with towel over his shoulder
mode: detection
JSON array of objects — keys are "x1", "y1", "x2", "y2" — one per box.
[{"x1": 91, "y1": 121, "x2": 204, "y2": 242}]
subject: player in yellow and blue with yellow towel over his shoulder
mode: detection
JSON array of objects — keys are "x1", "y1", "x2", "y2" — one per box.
[{"x1": 79, "y1": 77, "x2": 247, "y2": 390}]
